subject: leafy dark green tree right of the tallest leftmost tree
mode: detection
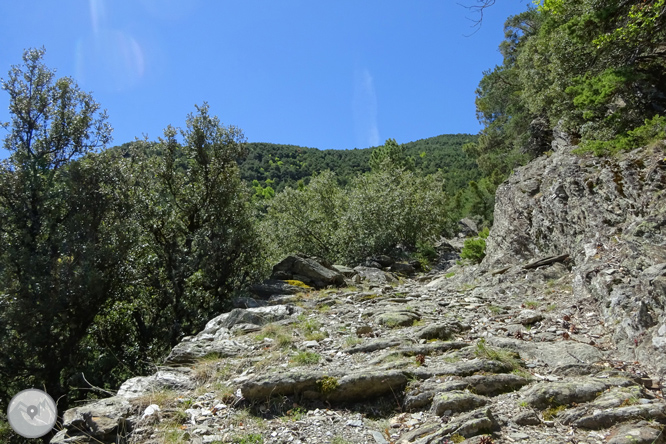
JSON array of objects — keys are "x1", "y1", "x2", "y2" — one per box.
[{"x1": 127, "y1": 104, "x2": 262, "y2": 347}]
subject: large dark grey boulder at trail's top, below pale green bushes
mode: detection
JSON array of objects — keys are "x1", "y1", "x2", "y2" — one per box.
[{"x1": 271, "y1": 254, "x2": 345, "y2": 288}]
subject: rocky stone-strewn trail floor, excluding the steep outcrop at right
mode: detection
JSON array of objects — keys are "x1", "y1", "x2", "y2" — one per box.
[{"x1": 50, "y1": 256, "x2": 666, "y2": 444}]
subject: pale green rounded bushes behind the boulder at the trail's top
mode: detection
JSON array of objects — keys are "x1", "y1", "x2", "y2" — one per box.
[{"x1": 261, "y1": 169, "x2": 448, "y2": 263}]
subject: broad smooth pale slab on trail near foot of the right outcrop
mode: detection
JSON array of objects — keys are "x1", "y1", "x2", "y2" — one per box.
[{"x1": 486, "y1": 336, "x2": 605, "y2": 368}]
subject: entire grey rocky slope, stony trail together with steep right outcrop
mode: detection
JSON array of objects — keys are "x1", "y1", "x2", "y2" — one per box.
[{"x1": 52, "y1": 143, "x2": 666, "y2": 444}]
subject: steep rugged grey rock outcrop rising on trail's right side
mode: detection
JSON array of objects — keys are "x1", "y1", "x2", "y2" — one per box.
[{"x1": 483, "y1": 141, "x2": 666, "y2": 375}]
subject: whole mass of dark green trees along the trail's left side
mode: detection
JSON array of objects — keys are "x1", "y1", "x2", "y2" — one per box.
[{"x1": 0, "y1": 50, "x2": 263, "y2": 420}]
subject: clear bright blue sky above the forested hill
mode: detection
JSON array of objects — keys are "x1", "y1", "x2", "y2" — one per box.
[{"x1": 0, "y1": 0, "x2": 528, "y2": 158}]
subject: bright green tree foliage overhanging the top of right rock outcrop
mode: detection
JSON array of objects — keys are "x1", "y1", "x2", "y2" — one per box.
[{"x1": 464, "y1": 0, "x2": 666, "y2": 199}]
